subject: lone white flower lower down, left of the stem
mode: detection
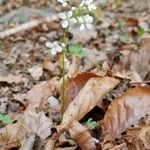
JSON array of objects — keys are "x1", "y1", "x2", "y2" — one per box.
[{"x1": 46, "y1": 41, "x2": 62, "y2": 55}]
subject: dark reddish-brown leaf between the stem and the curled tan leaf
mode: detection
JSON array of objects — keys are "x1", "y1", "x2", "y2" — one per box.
[{"x1": 65, "y1": 72, "x2": 97, "y2": 108}]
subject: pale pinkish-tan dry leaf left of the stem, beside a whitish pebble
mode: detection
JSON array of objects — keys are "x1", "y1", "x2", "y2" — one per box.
[{"x1": 26, "y1": 82, "x2": 53, "y2": 107}]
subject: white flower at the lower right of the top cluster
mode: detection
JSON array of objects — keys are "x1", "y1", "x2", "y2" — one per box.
[{"x1": 78, "y1": 15, "x2": 93, "y2": 31}]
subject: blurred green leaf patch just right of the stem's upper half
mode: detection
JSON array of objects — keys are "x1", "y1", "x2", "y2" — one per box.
[{"x1": 68, "y1": 43, "x2": 86, "y2": 58}]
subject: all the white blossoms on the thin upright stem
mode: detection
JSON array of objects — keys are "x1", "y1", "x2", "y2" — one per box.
[{"x1": 46, "y1": 0, "x2": 96, "y2": 55}]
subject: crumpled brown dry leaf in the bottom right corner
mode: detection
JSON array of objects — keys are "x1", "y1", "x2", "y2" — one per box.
[{"x1": 126, "y1": 126, "x2": 150, "y2": 150}]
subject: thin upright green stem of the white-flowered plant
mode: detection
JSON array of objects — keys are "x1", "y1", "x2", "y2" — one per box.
[{"x1": 61, "y1": 29, "x2": 67, "y2": 120}]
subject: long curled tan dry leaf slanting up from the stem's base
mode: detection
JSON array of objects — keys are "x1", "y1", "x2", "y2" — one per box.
[{"x1": 61, "y1": 76, "x2": 120, "y2": 128}]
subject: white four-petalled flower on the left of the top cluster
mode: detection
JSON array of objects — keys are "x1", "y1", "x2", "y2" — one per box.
[{"x1": 59, "y1": 11, "x2": 77, "y2": 28}]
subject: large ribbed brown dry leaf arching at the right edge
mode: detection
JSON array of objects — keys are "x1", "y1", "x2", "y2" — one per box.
[{"x1": 102, "y1": 87, "x2": 150, "y2": 141}]
